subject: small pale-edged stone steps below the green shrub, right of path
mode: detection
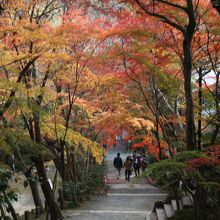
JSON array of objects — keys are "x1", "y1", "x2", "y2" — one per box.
[{"x1": 149, "y1": 194, "x2": 193, "y2": 220}]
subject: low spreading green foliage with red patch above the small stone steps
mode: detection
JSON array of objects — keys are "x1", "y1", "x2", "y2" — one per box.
[{"x1": 145, "y1": 151, "x2": 220, "y2": 198}]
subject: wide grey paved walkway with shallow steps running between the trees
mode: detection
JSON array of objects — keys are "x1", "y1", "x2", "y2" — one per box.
[{"x1": 65, "y1": 143, "x2": 166, "y2": 220}]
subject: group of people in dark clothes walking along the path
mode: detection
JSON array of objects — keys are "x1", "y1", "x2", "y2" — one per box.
[{"x1": 113, "y1": 152, "x2": 148, "y2": 181}]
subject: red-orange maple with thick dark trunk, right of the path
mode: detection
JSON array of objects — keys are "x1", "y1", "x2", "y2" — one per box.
[{"x1": 96, "y1": 1, "x2": 218, "y2": 149}]
